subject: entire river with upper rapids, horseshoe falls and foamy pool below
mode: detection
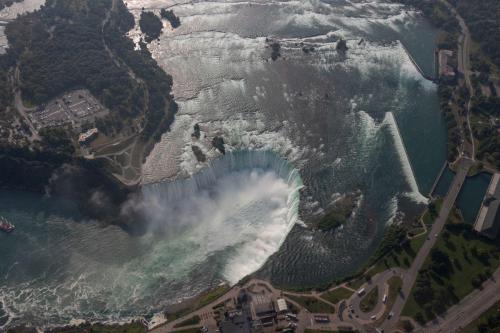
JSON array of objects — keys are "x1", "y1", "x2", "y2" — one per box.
[{"x1": 0, "y1": 0, "x2": 446, "y2": 326}]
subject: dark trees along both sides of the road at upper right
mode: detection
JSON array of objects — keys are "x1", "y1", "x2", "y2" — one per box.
[{"x1": 398, "y1": 0, "x2": 500, "y2": 169}]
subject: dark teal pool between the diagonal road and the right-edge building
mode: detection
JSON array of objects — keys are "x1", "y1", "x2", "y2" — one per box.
[{"x1": 456, "y1": 172, "x2": 491, "y2": 224}]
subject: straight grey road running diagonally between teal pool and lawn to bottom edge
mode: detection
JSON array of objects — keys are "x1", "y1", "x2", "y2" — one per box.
[{"x1": 382, "y1": 158, "x2": 473, "y2": 332}]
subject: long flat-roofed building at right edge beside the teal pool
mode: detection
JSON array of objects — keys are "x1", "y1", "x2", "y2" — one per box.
[{"x1": 474, "y1": 173, "x2": 500, "y2": 238}]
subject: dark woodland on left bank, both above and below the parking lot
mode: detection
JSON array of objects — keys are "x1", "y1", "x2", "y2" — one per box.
[{"x1": 0, "y1": 0, "x2": 177, "y2": 197}]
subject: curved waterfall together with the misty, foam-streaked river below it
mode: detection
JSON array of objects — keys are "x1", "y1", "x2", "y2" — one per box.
[{"x1": 0, "y1": 152, "x2": 302, "y2": 325}]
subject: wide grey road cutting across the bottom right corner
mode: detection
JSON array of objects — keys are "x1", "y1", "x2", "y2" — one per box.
[{"x1": 420, "y1": 268, "x2": 500, "y2": 333}]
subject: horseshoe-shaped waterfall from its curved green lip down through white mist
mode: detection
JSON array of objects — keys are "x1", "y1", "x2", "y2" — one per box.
[{"x1": 141, "y1": 151, "x2": 302, "y2": 283}]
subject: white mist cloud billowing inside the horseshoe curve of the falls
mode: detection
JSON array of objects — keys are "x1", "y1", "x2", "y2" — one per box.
[{"x1": 139, "y1": 169, "x2": 295, "y2": 283}]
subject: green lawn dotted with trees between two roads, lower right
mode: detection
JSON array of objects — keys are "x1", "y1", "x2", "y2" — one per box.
[{"x1": 403, "y1": 222, "x2": 500, "y2": 322}]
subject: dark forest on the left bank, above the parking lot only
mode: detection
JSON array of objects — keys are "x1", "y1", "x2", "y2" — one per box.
[{"x1": 6, "y1": 0, "x2": 176, "y2": 147}]
